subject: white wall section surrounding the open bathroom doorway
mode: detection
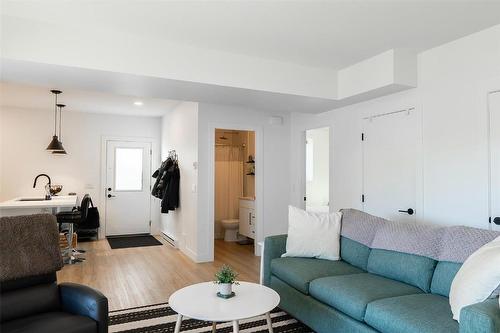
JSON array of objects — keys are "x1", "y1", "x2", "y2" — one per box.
[{"x1": 197, "y1": 104, "x2": 290, "y2": 261}]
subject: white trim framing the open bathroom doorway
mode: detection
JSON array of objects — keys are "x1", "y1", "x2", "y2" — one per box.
[{"x1": 207, "y1": 122, "x2": 264, "y2": 261}]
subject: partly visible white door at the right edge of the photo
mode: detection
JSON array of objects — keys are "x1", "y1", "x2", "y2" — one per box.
[{"x1": 488, "y1": 91, "x2": 500, "y2": 231}]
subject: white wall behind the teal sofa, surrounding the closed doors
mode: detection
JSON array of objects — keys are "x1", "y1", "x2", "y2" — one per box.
[{"x1": 290, "y1": 25, "x2": 500, "y2": 228}]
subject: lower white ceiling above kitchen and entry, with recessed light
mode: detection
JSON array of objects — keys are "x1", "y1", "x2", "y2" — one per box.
[{"x1": 0, "y1": 82, "x2": 180, "y2": 117}]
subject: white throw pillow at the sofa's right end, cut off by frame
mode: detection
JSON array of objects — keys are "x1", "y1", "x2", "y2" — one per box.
[{"x1": 450, "y1": 237, "x2": 500, "y2": 321}]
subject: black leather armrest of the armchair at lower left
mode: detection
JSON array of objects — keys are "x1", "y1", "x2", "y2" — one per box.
[{"x1": 59, "y1": 283, "x2": 108, "y2": 333}]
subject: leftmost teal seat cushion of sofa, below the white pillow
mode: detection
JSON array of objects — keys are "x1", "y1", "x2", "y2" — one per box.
[{"x1": 271, "y1": 258, "x2": 363, "y2": 295}]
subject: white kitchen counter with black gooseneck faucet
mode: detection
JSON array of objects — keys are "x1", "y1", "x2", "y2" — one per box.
[{"x1": 0, "y1": 195, "x2": 78, "y2": 216}]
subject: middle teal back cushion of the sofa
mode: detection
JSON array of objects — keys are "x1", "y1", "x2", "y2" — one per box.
[{"x1": 367, "y1": 249, "x2": 437, "y2": 292}]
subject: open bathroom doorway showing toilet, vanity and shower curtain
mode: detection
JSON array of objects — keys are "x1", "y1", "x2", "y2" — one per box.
[{"x1": 214, "y1": 128, "x2": 257, "y2": 256}]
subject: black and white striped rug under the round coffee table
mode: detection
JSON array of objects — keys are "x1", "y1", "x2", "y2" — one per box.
[{"x1": 109, "y1": 303, "x2": 313, "y2": 333}]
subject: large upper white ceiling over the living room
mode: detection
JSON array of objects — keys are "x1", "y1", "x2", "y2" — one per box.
[{"x1": 2, "y1": 0, "x2": 500, "y2": 69}]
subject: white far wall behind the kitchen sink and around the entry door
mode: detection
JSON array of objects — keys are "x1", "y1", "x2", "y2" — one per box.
[{"x1": 0, "y1": 107, "x2": 160, "y2": 234}]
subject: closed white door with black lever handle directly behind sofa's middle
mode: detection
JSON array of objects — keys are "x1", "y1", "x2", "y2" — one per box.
[{"x1": 362, "y1": 109, "x2": 418, "y2": 222}]
